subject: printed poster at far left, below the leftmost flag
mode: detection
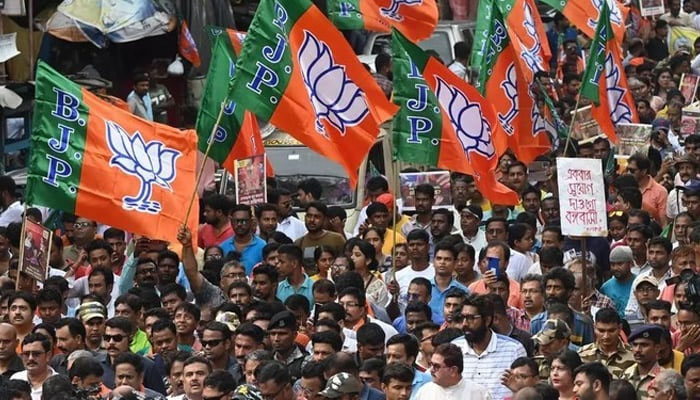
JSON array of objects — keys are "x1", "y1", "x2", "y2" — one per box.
[{"x1": 19, "y1": 218, "x2": 52, "y2": 282}]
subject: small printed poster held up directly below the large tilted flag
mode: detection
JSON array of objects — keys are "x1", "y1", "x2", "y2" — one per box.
[{"x1": 234, "y1": 153, "x2": 267, "y2": 206}]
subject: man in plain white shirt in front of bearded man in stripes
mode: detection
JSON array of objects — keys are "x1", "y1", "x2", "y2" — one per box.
[{"x1": 415, "y1": 343, "x2": 491, "y2": 400}]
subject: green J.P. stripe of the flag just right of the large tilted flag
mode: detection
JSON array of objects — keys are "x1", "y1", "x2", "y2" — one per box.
[{"x1": 392, "y1": 29, "x2": 442, "y2": 166}]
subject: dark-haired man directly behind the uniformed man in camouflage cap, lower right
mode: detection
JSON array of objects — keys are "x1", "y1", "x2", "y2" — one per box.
[{"x1": 530, "y1": 267, "x2": 594, "y2": 346}]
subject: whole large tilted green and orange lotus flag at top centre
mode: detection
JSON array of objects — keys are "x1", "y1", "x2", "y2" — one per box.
[{"x1": 230, "y1": 0, "x2": 397, "y2": 187}]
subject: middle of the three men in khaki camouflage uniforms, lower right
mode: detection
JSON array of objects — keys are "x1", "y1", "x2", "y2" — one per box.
[{"x1": 578, "y1": 308, "x2": 635, "y2": 379}]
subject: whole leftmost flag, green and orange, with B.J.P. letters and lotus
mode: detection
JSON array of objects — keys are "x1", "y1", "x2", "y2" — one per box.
[{"x1": 26, "y1": 61, "x2": 199, "y2": 243}]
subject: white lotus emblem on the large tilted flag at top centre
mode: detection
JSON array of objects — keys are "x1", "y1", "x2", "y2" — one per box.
[{"x1": 298, "y1": 30, "x2": 369, "y2": 138}]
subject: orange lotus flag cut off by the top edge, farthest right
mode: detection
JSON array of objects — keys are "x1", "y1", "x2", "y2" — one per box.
[{"x1": 542, "y1": 0, "x2": 629, "y2": 45}]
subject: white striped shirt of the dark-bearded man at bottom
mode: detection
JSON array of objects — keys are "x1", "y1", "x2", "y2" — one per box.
[{"x1": 452, "y1": 331, "x2": 527, "y2": 400}]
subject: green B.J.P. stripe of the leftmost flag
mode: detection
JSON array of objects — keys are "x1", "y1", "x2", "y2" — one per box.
[{"x1": 26, "y1": 61, "x2": 89, "y2": 212}]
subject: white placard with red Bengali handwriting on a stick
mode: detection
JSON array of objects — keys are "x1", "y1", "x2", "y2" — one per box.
[{"x1": 557, "y1": 158, "x2": 608, "y2": 237}]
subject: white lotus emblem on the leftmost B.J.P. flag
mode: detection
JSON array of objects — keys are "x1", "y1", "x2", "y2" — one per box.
[{"x1": 105, "y1": 121, "x2": 182, "y2": 214}]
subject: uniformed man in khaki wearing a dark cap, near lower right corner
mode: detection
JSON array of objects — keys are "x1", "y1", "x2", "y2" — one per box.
[{"x1": 623, "y1": 325, "x2": 663, "y2": 400}]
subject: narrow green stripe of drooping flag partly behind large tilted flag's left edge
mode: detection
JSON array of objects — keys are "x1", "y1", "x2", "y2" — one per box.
[{"x1": 196, "y1": 34, "x2": 245, "y2": 163}]
